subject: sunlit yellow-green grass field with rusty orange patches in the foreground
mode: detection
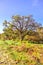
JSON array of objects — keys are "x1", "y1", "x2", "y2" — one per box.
[{"x1": 0, "y1": 40, "x2": 43, "y2": 65}]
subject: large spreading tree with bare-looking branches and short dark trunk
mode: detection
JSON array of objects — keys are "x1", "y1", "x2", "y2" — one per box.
[{"x1": 3, "y1": 15, "x2": 40, "y2": 41}]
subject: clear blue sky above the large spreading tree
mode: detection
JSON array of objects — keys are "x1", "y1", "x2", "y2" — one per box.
[{"x1": 0, "y1": 0, "x2": 43, "y2": 33}]
